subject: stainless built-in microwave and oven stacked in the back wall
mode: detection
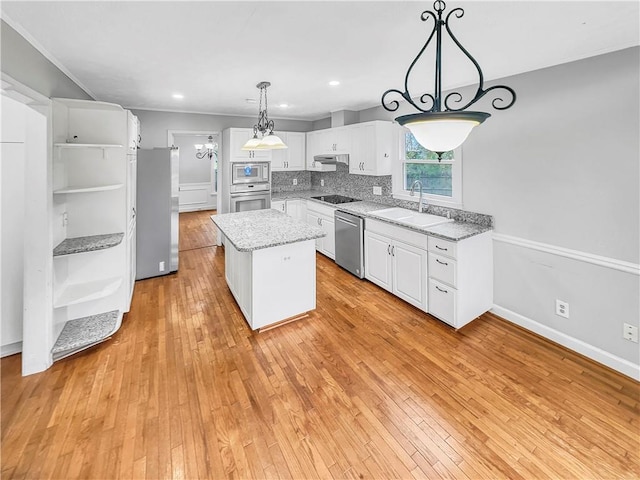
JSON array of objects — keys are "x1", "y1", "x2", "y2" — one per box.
[{"x1": 229, "y1": 162, "x2": 271, "y2": 212}]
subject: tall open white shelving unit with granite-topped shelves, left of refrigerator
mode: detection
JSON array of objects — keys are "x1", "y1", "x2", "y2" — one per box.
[{"x1": 51, "y1": 99, "x2": 138, "y2": 360}]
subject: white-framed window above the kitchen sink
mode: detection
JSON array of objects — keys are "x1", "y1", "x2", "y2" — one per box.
[{"x1": 393, "y1": 132, "x2": 462, "y2": 206}]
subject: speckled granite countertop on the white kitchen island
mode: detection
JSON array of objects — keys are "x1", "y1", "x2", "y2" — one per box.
[{"x1": 211, "y1": 208, "x2": 326, "y2": 252}]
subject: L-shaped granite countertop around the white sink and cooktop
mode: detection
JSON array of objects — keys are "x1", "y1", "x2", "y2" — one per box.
[{"x1": 272, "y1": 190, "x2": 493, "y2": 241}]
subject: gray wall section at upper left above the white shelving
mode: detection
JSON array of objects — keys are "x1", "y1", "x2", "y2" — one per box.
[{"x1": 0, "y1": 20, "x2": 93, "y2": 100}]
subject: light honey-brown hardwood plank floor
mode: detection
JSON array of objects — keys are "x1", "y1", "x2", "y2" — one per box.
[{"x1": 1, "y1": 212, "x2": 640, "y2": 479}]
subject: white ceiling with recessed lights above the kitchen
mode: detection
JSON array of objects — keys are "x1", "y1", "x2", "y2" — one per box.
[{"x1": 1, "y1": 0, "x2": 640, "y2": 120}]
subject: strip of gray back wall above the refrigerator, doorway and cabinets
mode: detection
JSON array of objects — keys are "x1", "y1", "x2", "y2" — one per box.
[{"x1": 131, "y1": 107, "x2": 312, "y2": 148}]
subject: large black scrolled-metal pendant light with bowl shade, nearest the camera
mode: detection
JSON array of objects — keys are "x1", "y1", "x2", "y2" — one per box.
[{"x1": 382, "y1": 0, "x2": 516, "y2": 159}]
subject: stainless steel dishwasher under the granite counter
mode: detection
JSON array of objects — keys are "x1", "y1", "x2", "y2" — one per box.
[{"x1": 335, "y1": 210, "x2": 364, "y2": 278}]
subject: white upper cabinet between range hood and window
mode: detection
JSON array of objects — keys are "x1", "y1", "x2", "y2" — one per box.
[{"x1": 348, "y1": 121, "x2": 399, "y2": 176}]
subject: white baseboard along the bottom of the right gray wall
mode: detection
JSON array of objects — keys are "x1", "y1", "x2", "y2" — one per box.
[{"x1": 491, "y1": 305, "x2": 640, "y2": 381}]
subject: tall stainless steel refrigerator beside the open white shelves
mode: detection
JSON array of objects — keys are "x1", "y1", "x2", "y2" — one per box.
[{"x1": 136, "y1": 147, "x2": 179, "y2": 280}]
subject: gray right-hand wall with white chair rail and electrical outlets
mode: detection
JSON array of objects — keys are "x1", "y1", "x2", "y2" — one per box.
[{"x1": 360, "y1": 47, "x2": 640, "y2": 374}]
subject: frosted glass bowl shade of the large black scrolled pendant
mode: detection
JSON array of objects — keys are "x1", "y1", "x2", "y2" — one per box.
[{"x1": 396, "y1": 112, "x2": 491, "y2": 152}]
